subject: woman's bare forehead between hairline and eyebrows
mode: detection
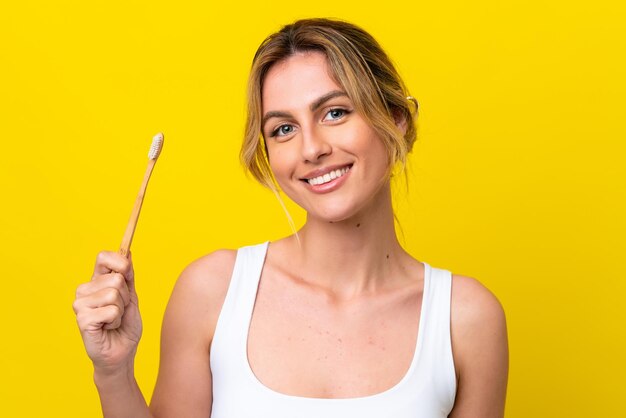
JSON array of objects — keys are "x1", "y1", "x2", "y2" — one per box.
[{"x1": 262, "y1": 51, "x2": 344, "y2": 113}]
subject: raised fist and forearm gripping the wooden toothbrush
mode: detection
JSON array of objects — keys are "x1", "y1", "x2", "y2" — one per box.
[{"x1": 73, "y1": 251, "x2": 151, "y2": 418}]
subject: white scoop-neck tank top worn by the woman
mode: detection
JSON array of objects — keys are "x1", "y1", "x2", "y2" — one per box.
[{"x1": 211, "y1": 242, "x2": 456, "y2": 418}]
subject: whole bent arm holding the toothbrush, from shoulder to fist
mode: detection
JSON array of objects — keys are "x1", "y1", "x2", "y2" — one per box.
[{"x1": 74, "y1": 251, "x2": 236, "y2": 418}]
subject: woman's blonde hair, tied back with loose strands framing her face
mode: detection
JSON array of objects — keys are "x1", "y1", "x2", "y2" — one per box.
[{"x1": 240, "y1": 19, "x2": 418, "y2": 191}]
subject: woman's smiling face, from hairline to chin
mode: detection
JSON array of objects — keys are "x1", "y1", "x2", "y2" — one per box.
[{"x1": 262, "y1": 52, "x2": 389, "y2": 222}]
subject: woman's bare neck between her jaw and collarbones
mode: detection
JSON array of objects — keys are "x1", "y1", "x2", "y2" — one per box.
[{"x1": 294, "y1": 185, "x2": 407, "y2": 298}]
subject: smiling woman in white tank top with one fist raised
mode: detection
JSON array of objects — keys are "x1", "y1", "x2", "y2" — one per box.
[{"x1": 74, "y1": 19, "x2": 508, "y2": 418}]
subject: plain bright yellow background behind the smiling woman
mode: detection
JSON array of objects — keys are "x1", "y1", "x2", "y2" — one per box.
[{"x1": 0, "y1": 0, "x2": 626, "y2": 418}]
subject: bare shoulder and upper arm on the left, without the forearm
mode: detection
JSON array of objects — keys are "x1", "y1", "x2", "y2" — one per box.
[{"x1": 150, "y1": 251, "x2": 236, "y2": 418}]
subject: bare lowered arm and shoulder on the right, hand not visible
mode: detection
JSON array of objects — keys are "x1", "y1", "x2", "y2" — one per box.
[{"x1": 449, "y1": 275, "x2": 509, "y2": 418}]
